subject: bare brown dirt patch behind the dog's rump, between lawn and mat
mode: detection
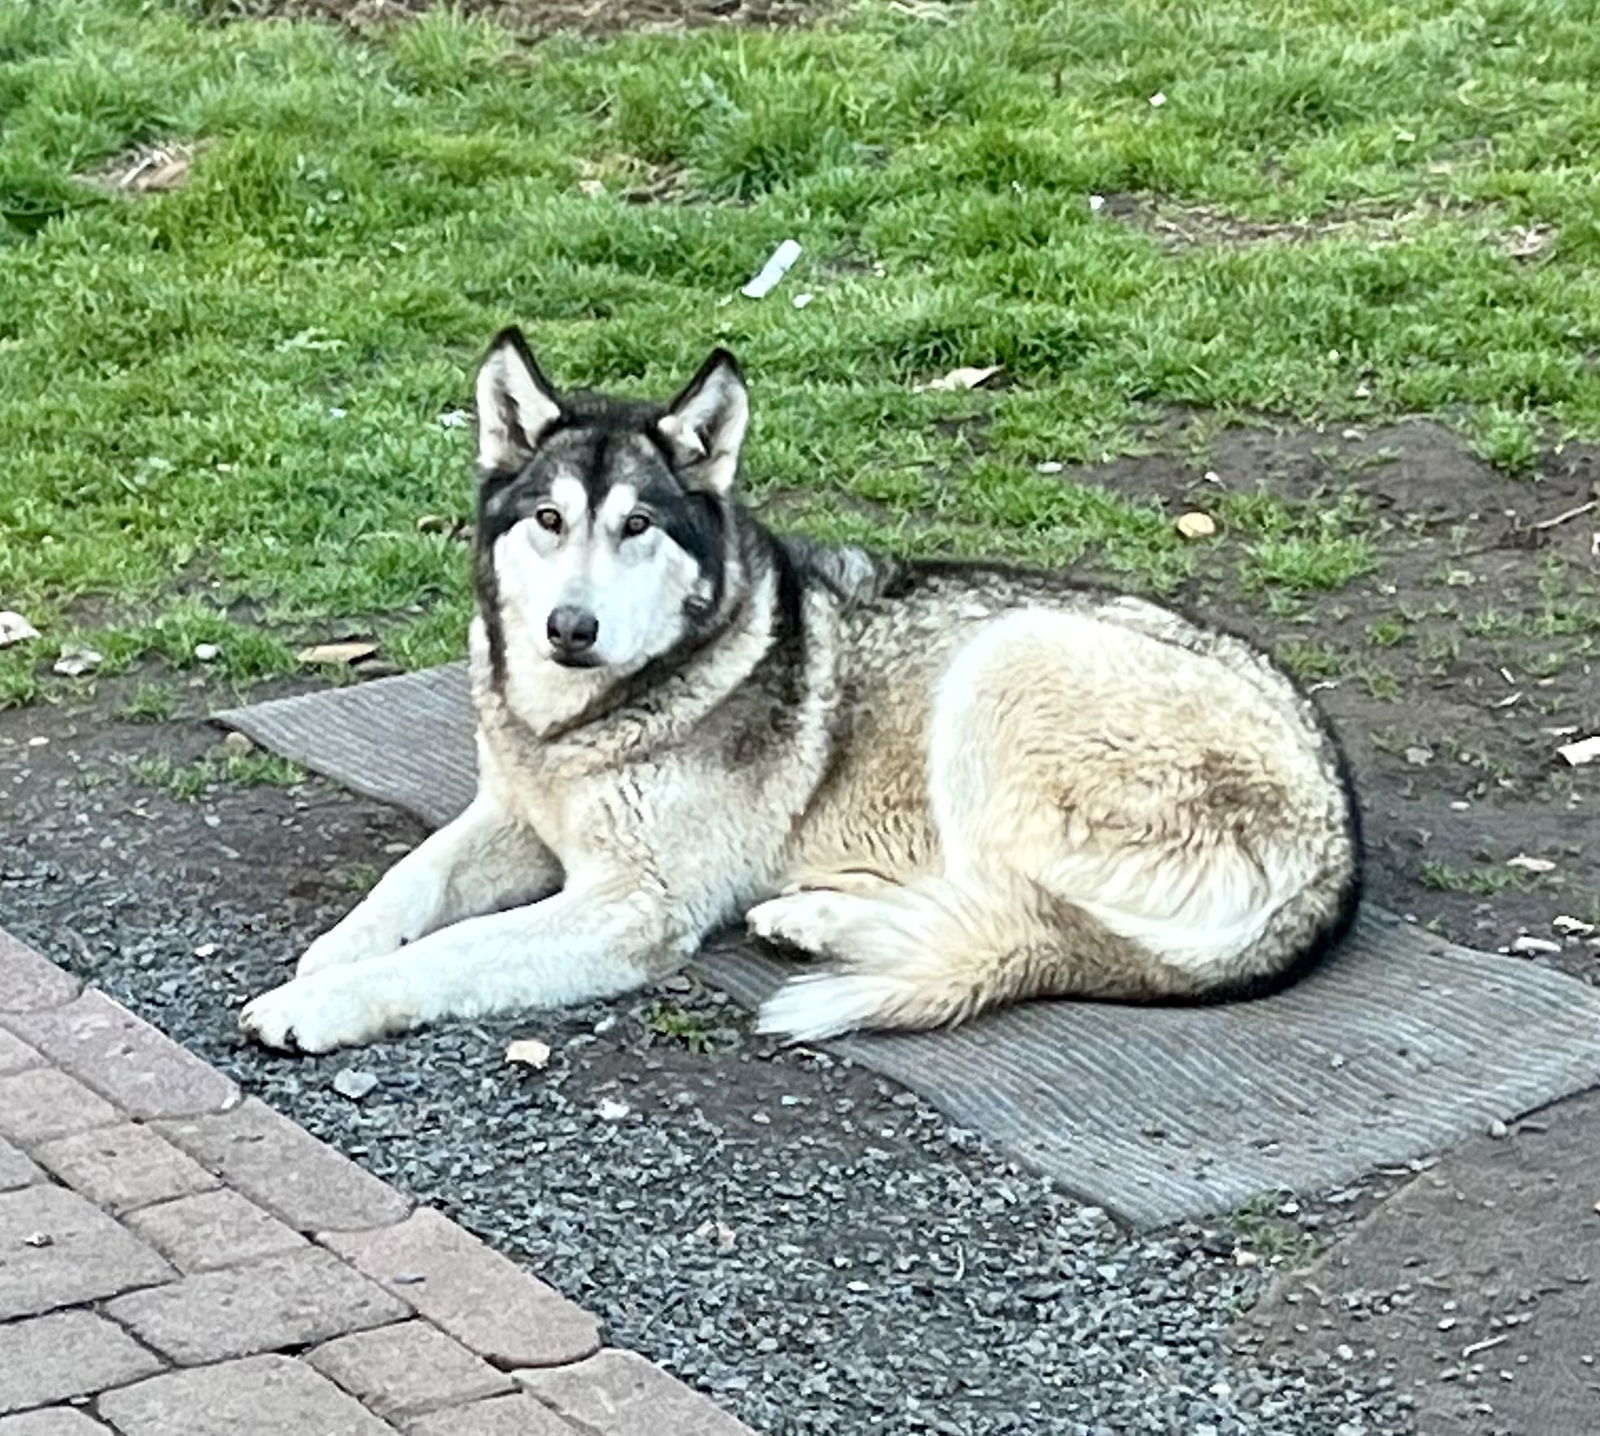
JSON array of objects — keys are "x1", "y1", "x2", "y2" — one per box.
[{"x1": 1062, "y1": 422, "x2": 1600, "y2": 982}]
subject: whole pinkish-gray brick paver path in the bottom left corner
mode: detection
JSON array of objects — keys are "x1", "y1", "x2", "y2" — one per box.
[{"x1": 0, "y1": 932, "x2": 750, "y2": 1436}]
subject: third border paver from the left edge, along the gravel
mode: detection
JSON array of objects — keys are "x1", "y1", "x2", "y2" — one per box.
[{"x1": 154, "y1": 1097, "x2": 411, "y2": 1231}]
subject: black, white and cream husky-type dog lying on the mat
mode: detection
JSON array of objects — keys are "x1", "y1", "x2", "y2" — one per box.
[{"x1": 242, "y1": 329, "x2": 1360, "y2": 1052}]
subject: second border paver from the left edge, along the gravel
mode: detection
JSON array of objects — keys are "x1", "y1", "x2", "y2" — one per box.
[{"x1": 0, "y1": 991, "x2": 240, "y2": 1118}]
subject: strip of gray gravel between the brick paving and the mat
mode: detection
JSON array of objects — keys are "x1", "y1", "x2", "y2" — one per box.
[{"x1": 0, "y1": 710, "x2": 1411, "y2": 1436}]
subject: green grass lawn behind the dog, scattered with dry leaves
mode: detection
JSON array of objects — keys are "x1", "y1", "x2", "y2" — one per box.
[{"x1": 0, "y1": 0, "x2": 1600, "y2": 705}]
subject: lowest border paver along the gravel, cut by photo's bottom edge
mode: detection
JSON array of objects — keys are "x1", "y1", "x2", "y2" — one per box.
[{"x1": 517, "y1": 1351, "x2": 747, "y2": 1436}]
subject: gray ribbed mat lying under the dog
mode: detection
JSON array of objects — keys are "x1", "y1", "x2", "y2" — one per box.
[{"x1": 219, "y1": 665, "x2": 1600, "y2": 1223}]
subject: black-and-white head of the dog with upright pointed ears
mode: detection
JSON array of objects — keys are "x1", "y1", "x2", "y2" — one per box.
[{"x1": 477, "y1": 329, "x2": 749, "y2": 673}]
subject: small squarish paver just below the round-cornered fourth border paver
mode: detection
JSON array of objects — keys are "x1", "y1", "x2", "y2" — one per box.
[{"x1": 306, "y1": 1321, "x2": 515, "y2": 1417}]
